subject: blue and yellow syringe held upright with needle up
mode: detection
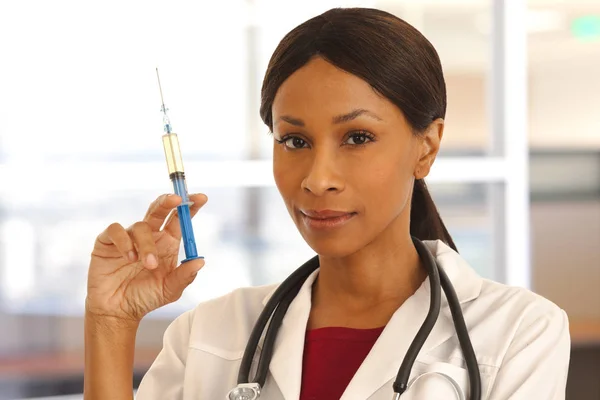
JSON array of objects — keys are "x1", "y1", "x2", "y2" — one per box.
[{"x1": 156, "y1": 68, "x2": 204, "y2": 262}]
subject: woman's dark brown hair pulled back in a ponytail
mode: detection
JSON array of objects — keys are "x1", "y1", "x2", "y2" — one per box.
[{"x1": 260, "y1": 8, "x2": 456, "y2": 250}]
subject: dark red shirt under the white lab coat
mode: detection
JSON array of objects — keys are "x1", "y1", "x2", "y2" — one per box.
[{"x1": 300, "y1": 327, "x2": 383, "y2": 400}]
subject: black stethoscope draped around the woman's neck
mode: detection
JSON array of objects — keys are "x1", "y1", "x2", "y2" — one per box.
[{"x1": 228, "y1": 237, "x2": 481, "y2": 400}]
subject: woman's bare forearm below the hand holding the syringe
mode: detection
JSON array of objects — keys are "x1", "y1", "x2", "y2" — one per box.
[{"x1": 83, "y1": 313, "x2": 138, "y2": 400}]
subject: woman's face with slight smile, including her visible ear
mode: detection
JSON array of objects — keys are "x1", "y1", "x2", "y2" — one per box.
[{"x1": 272, "y1": 58, "x2": 443, "y2": 257}]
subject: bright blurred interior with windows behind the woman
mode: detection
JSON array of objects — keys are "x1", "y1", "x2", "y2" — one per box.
[{"x1": 0, "y1": 0, "x2": 600, "y2": 400}]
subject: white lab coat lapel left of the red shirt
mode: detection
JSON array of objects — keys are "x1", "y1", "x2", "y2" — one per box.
[{"x1": 265, "y1": 270, "x2": 318, "y2": 400}]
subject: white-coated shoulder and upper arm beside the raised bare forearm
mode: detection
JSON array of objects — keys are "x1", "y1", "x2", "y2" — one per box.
[{"x1": 136, "y1": 285, "x2": 277, "y2": 399}]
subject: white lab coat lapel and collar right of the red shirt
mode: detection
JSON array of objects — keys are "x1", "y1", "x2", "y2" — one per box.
[{"x1": 340, "y1": 242, "x2": 481, "y2": 400}]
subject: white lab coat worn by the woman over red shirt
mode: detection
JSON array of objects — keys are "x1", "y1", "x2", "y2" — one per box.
[{"x1": 136, "y1": 241, "x2": 570, "y2": 400}]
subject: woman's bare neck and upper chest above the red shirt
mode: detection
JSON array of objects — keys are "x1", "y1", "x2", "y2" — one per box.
[{"x1": 309, "y1": 219, "x2": 427, "y2": 328}]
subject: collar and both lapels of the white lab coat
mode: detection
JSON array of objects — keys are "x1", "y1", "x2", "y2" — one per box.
[{"x1": 263, "y1": 241, "x2": 482, "y2": 400}]
